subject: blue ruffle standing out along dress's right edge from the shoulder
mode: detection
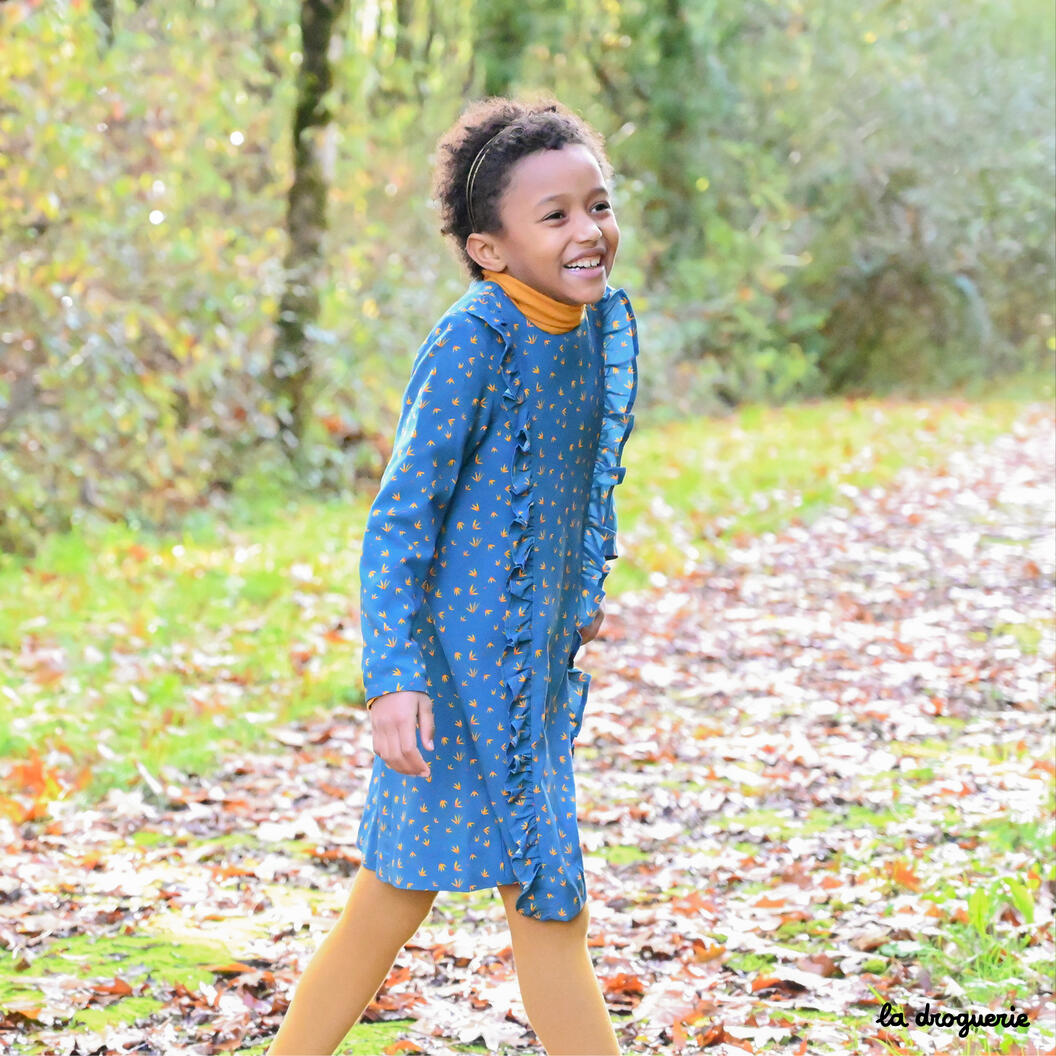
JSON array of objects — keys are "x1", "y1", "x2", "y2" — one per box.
[{"x1": 577, "y1": 289, "x2": 638, "y2": 627}]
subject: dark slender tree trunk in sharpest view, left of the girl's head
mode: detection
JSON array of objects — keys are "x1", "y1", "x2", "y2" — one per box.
[{"x1": 270, "y1": 0, "x2": 346, "y2": 460}]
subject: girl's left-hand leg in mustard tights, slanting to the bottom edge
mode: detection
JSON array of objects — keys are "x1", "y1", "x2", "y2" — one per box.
[{"x1": 267, "y1": 866, "x2": 436, "y2": 1056}]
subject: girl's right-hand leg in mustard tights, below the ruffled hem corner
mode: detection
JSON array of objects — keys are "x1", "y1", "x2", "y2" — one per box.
[{"x1": 498, "y1": 884, "x2": 620, "y2": 1056}]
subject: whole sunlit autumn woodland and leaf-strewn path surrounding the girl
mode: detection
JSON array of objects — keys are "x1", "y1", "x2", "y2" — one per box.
[{"x1": 0, "y1": 0, "x2": 1056, "y2": 1056}]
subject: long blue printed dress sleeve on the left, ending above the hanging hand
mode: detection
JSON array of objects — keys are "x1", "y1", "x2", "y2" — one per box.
[{"x1": 359, "y1": 315, "x2": 495, "y2": 708}]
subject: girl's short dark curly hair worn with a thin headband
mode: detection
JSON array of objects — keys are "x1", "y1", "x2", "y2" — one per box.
[{"x1": 432, "y1": 96, "x2": 612, "y2": 279}]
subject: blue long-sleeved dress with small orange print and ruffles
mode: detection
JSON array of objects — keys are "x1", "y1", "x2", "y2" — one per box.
[{"x1": 356, "y1": 280, "x2": 638, "y2": 920}]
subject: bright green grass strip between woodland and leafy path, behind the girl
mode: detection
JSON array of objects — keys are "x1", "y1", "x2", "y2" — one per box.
[{"x1": 0, "y1": 379, "x2": 1053, "y2": 808}]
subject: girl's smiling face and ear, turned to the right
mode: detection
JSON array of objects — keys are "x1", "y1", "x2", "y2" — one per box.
[{"x1": 466, "y1": 143, "x2": 620, "y2": 304}]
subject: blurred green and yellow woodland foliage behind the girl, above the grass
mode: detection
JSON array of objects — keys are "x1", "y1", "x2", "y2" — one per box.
[{"x1": 0, "y1": 0, "x2": 1056, "y2": 553}]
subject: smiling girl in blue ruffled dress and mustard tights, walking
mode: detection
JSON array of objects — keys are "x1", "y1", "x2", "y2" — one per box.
[{"x1": 268, "y1": 98, "x2": 638, "y2": 1056}]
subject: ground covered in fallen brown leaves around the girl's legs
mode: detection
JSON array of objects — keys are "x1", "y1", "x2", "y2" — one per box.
[{"x1": 0, "y1": 408, "x2": 1056, "y2": 1056}]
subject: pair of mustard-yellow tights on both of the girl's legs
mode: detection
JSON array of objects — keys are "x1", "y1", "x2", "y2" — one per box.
[{"x1": 267, "y1": 866, "x2": 620, "y2": 1056}]
